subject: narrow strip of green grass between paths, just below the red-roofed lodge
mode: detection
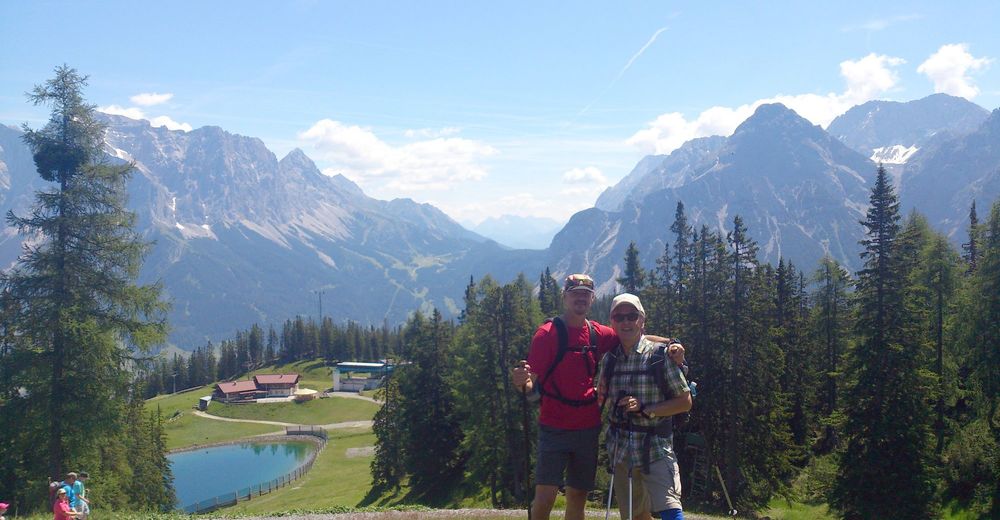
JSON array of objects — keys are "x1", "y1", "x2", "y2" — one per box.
[{"x1": 208, "y1": 397, "x2": 379, "y2": 425}]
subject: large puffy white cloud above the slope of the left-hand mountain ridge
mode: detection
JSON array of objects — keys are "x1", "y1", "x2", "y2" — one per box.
[{"x1": 298, "y1": 119, "x2": 497, "y2": 190}]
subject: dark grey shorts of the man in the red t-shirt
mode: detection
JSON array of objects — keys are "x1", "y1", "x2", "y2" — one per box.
[{"x1": 535, "y1": 424, "x2": 601, "y2": 491}]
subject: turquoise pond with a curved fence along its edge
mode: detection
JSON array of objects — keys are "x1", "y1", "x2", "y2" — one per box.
[{"x1": 167, "y1": 441, "x2": 316, "y2": 507}]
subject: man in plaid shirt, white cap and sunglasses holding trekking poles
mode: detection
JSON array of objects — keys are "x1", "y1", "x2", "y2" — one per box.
[{"x1": 598, "y1": 293, "x2": 691, "y2": 520}]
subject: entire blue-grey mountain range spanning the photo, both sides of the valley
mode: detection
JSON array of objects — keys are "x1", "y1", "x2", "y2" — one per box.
[{"x1": 0, "y1": 94, "x2": 1000, "y2": 349}]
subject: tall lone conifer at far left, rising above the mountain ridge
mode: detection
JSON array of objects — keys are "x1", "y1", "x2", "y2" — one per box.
[{"x1": 3, "y1": 66, "x2": 166, "y2": 488}]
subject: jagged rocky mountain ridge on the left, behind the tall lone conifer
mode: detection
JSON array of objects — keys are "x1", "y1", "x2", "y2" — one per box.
[{"x1": 0, "y1": 116, "x2": 543, "y2": 348}]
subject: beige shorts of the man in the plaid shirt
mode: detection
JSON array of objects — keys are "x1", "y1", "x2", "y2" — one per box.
[{"x1": 615, "y1": 453, "x2": 681, "y2": 520}]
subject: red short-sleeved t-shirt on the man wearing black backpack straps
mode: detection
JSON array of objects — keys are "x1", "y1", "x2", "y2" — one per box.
[{"x1": 528, "y1": 321, "x2": 618, "y2": 430}]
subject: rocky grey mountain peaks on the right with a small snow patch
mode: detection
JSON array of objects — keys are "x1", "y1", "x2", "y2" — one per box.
[{"x1": 548, "y1": 94, "x2": 1000, "y2": 292}]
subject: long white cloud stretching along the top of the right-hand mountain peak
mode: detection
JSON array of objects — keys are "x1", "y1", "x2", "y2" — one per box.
[{"x1": 626, "y1": 54, "x2": 905, "y2": 154}]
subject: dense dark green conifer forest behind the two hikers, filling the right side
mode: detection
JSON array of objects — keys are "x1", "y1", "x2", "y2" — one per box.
[{"x1": 372, "y1": 168, "x2": 1000, "y2": 518}]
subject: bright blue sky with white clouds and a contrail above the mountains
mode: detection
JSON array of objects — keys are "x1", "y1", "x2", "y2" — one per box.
[{"x1": 0, "y1": 0, "x2": 1000, "y2": 226}]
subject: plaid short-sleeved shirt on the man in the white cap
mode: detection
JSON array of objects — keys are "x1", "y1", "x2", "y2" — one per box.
[{"x1": 598, "y1": 336, "x2": 690, "y2": 467}]
